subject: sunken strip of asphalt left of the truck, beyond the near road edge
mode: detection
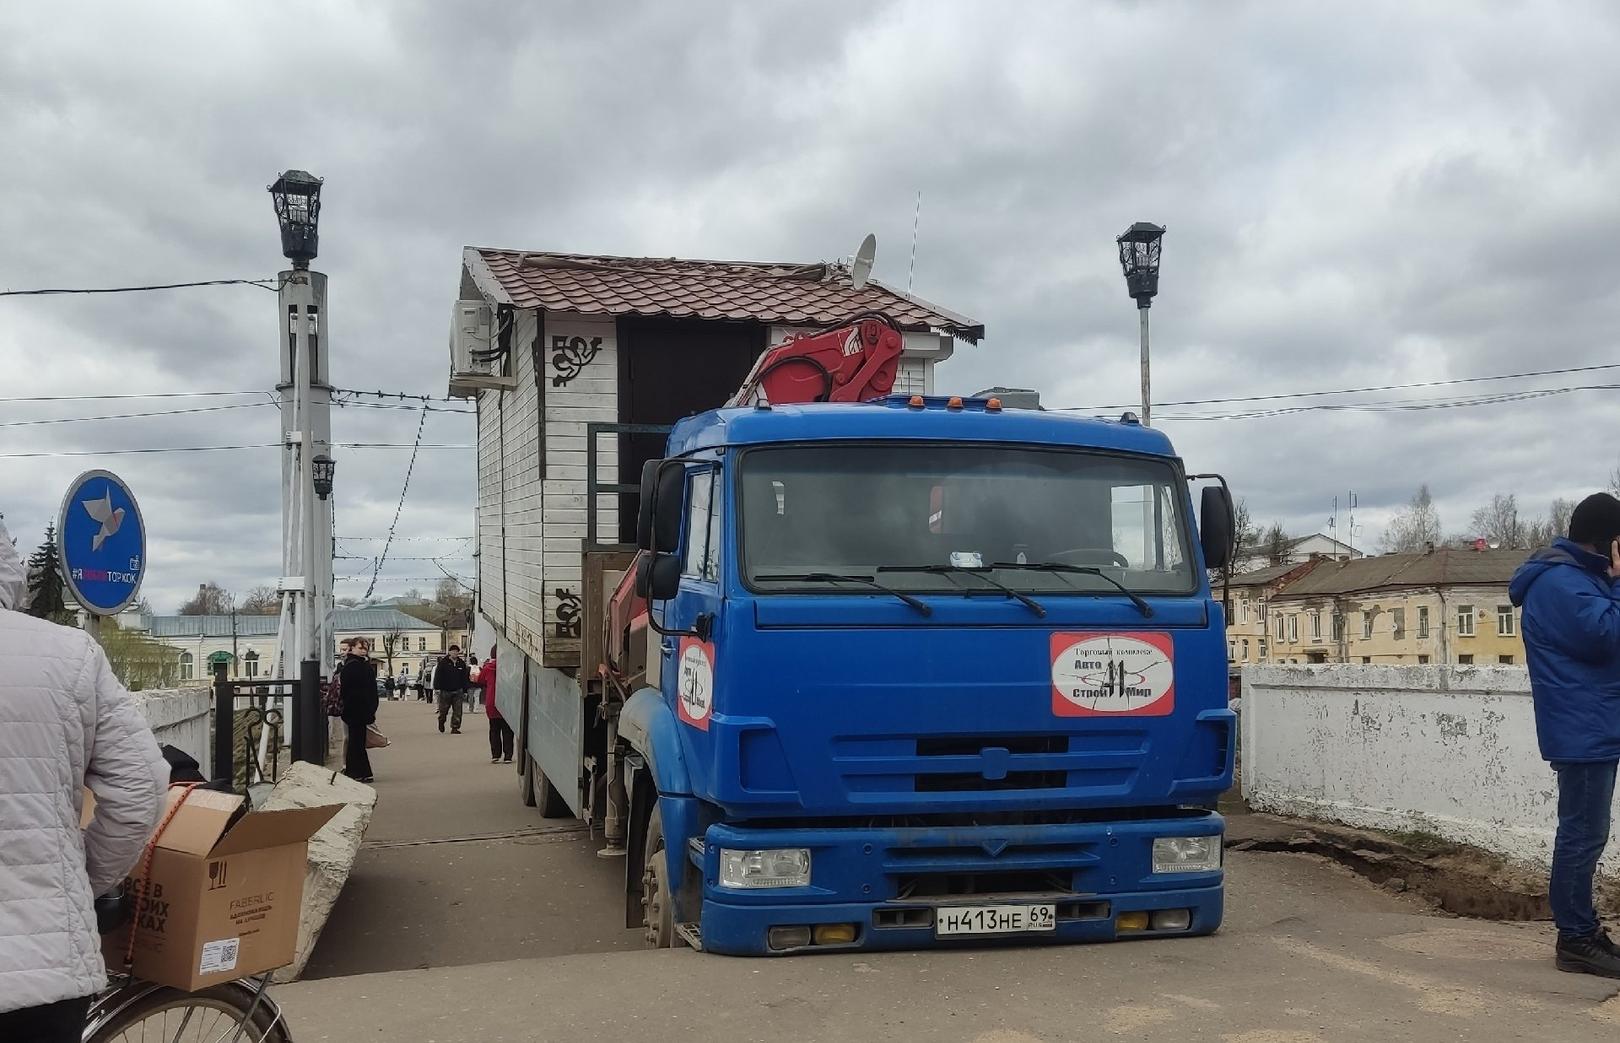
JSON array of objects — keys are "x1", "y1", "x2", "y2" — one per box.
[{"x1": 305, "y1": 700, "x2": 642, "y2": 978}]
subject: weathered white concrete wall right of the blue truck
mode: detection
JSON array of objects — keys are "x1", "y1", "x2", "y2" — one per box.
[{"x1": 1241, "y1": 666, "x2": 1620, "y2": 871}]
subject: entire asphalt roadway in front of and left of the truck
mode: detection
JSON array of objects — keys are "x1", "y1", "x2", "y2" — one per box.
[{"x1": 291, "y1": 703, "x2": 1620, "y2": 1043}]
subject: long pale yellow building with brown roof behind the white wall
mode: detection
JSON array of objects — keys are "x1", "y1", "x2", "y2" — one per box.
[{"x1": 1265, "y1": 547, "x2": 1526, "y2": 666}]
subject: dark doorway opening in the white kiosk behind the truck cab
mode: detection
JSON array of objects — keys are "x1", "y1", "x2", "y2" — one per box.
[{"x1": 619, "y1": 317, "x2": 766, "y2": 543}]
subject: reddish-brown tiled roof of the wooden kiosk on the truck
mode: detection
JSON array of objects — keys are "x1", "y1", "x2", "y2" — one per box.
[{"x1": 463, "y1": 246, "x2": 985, "y2": 343}]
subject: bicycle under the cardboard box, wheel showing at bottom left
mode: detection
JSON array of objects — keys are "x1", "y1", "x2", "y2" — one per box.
[{"x1": 83, "y1": 892, "x2": 292, "y2": 1043}]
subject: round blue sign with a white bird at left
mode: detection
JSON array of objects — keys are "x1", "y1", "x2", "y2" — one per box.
[{"x1": 57, "y1": 471, "x2": 146, "y2": 615}]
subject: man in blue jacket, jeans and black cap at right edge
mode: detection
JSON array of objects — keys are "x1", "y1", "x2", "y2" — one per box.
[{"x1": 1508, "y1": 492, "x2": 1620, "y2": 978}]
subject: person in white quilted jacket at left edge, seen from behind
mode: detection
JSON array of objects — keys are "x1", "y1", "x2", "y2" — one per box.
[{"x1": 0, "y1": 523, "x2": 168, "y2": 1043}]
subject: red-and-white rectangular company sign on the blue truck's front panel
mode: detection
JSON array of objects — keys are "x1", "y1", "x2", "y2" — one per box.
[{"x1": 1051, "y1": 632, "x2": 1176, "y2": 717}]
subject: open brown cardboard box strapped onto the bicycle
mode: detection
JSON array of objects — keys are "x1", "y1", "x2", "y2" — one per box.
[{"x1": 134, "y1": 789, "x2": 342, "y2": 991}]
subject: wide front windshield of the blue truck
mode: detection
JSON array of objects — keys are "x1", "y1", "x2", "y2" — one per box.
[{"x1": 739, "y1": 442, "x2": 1197, "y2": 596}]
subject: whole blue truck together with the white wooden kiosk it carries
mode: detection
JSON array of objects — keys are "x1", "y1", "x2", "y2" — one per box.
[{"x1": 450, "y1": 248, "x2": 1236, "y2": 954}]
